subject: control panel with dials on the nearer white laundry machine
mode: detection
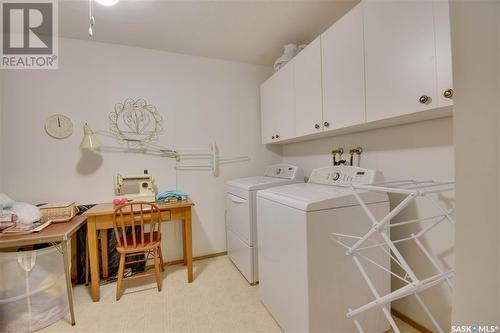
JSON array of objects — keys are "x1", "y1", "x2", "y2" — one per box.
[{"x1": 308, "y1": 166, "x2": 382, "y2": 186}]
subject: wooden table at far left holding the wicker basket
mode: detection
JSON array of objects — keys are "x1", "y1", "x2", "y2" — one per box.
[{"x1": 0, "y1": 215, "x2": 86, "y2": 325}]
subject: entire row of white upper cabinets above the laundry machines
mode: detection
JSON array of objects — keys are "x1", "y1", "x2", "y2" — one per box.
[{"x1": 261, "y1": 0, "x2": 453, "y2": 143}]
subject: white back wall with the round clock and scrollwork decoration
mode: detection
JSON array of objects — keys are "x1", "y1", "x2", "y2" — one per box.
[{"x1": 2, "y1": 39, "x2": 280, "y2": 260}]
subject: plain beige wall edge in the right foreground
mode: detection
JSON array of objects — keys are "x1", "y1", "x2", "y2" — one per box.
[{"x1": 450, "y1": 1, "x2": 500, "y2": 325}]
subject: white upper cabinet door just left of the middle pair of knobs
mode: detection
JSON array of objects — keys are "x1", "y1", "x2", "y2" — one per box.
[{"x1": 293, "y1": 37, "x2": 323, "y2": 136}]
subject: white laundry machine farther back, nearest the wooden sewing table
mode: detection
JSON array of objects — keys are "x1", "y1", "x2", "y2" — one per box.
[{"x1": 226, "y1": 164, "x2": 304, "y2": 284}]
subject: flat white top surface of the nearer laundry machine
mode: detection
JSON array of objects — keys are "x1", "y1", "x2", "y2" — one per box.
[{"x1": 257, "y1": 183, "x2": 389, "y2": 211}]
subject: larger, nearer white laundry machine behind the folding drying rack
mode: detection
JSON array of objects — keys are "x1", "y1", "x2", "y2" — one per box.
[{"x1": 257, "y1": 166, "x2": 390, "y2": 333}]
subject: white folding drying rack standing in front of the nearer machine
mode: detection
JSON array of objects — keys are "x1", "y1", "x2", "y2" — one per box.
[{"x1": 332, "y1": 180, "x2": 455, "y2": 333}]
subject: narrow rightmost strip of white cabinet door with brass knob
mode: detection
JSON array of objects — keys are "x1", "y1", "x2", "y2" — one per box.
[{"x1": 433, "y1": 1, "x2": 453, "y2": 106}]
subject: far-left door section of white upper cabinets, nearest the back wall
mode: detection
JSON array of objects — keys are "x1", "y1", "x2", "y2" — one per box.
[{"x1": 260, "y1": 63, "x2": 295, "y2": 143}]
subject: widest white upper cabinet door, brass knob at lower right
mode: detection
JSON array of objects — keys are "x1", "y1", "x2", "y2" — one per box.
[{"x1": 363, "y1": 0, "x2": 437, "y2": 121}]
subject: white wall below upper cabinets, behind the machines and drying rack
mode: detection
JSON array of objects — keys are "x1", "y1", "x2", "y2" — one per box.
[{"x1": 283, "y1": 118, "x2": 454, "y2": 330}]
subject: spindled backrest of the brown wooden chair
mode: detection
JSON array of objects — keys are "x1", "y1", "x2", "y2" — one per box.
[{"x1": 113, "y1": 202, "x2": 160, "y2": 248}]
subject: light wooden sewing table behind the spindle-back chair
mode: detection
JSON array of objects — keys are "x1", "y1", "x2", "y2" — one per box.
[{"x1": 83, "y1": 201, "x2": 194, "y2": 302}]
